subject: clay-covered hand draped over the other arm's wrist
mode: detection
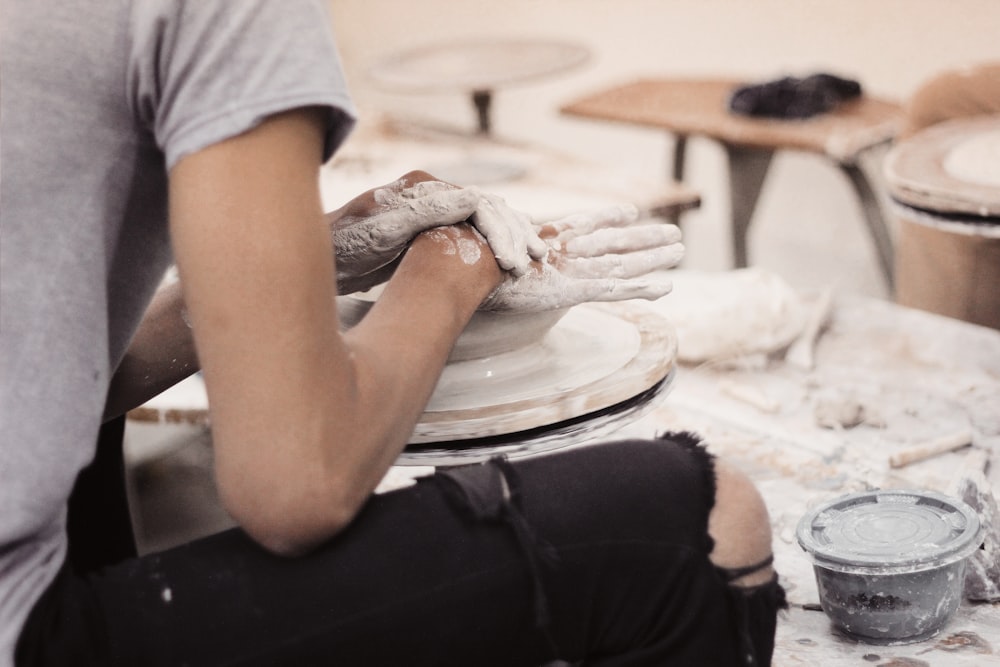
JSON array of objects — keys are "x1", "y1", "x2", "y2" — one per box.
[{"x1": 326, "y1": 171, "x2": 548, "y2": 294}]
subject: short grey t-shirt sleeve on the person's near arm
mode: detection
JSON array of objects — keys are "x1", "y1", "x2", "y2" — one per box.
[{"x1": 126, "y1": 0, "x2": 356, "y2": 169}]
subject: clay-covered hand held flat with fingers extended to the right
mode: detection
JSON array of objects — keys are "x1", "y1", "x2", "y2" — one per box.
[{"x1": 480, "y1": 205, "x2": 684, "y2": 312}]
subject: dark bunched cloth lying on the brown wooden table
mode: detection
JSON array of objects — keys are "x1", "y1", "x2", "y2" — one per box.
[{"x1": 729, "y1": 73, "x2": 861, "y2": 119}]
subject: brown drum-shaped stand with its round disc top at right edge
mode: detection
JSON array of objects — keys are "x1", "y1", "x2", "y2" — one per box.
[{"x1": 885, "y1": 115, "x2": 1000, "y2": 329}]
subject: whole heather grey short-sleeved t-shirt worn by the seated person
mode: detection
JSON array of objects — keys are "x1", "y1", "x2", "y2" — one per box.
[{"x1": 0, "y1": 0, "x2": 354, "y2": 665}]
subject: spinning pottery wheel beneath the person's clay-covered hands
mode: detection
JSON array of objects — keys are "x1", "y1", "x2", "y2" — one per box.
[{"x1": 400, "y1": 302, "x2": 677, "y2": 465}]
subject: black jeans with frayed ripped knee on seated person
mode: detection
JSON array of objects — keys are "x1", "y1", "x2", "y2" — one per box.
[{"x1": 18, "y1": 435, "x2": 784, "y2": 667}]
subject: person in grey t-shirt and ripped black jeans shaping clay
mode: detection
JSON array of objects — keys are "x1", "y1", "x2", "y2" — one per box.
[{"x1": 0, "y1": 0, "x2": 781, "y2": 666}]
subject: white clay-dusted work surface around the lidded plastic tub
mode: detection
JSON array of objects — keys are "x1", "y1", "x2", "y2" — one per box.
[{"x1": 623, "y1": 284, "x2": 1000, "y2": 667}]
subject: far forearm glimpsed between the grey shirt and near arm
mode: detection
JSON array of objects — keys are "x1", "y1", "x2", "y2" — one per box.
[{"x1": 104, "y1": 282, "x2": 199, "y2": 420}]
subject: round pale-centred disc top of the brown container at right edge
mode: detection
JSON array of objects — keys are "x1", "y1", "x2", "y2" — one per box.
[{"x1": 885, "y1": 115, "x2": 1000, "y2": 218}]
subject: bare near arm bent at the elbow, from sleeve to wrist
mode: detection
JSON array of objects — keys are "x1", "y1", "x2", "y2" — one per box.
[{"x1": 170, "y1": 110, "x2": 500, "y2": 554}]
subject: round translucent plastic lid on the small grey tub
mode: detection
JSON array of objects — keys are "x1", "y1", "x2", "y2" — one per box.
[{"x1": 796, "y1": 490, "x2": 982, "y2": 573}]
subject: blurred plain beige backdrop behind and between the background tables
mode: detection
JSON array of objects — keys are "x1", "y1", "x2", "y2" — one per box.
[{"x1": 331, "y1": 0, "x2": 1000, "y2": 292}]
